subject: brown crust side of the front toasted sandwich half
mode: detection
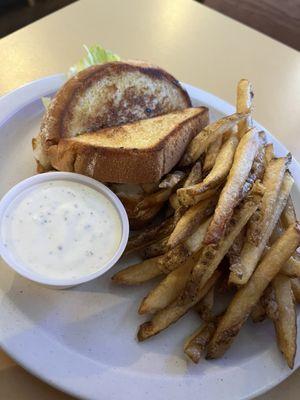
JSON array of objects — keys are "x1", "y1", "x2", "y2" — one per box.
[{"x1": 48, "y1": 107, "x2": 208, "y2": 184}]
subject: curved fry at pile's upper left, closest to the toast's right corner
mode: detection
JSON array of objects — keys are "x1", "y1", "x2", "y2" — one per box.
[{"x1": 180, "y1": 113, "x2": 249, "y2": 166}]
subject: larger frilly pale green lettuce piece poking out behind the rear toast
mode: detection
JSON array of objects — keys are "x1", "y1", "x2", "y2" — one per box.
[{"x1": 68, "y1": 44, "x2": 120, "y2": 78}]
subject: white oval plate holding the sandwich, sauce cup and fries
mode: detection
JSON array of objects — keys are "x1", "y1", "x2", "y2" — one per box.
[{"x1": 0, "y1": 75, "x2": 300, "y2": 400}]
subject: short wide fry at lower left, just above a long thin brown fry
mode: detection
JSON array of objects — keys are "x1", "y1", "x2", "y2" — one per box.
[{"x1": 139, "y1": 255, "x2": 195, "y2": 314}]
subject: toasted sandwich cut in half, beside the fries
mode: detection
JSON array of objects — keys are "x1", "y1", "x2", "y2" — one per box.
[{"x1": 32, "y1": 55, "x2": 208, "y2": 227}]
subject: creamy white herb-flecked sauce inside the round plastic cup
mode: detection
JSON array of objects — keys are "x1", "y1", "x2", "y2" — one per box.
[{"x1": 1, "y1": 180, "x2": 122, "y2": 279}]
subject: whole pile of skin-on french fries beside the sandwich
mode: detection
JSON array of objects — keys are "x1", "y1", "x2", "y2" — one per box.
[{"x1": 112, "y1": 79, "x2": 300, "y2": 368}]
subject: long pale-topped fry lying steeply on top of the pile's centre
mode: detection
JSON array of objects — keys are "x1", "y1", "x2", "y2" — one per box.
[{"x1": 204, "y1": 129, "x2": 259, "y2": 244}]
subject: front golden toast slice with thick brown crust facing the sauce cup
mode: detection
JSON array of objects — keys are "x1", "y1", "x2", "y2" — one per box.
[{"x1": 48, "y1": 107, "x2": 208, "y2": 184}]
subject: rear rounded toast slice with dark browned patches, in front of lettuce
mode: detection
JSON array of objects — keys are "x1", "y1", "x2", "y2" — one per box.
[{"x1": 33, "y1": 61, "x2": 191, "y2": 170}]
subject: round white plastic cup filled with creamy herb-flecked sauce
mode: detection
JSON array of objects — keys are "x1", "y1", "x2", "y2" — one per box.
[{"x1": 0, "y1": 172, "x2": 129, "y2": 288}]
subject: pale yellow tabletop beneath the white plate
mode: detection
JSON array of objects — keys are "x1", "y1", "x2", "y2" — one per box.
[{"x1": 0, "y1": 0, "x2": 300, "y2": 400}]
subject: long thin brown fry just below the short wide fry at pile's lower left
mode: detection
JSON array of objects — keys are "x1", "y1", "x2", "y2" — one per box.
[{"x1": 137, "y1": 271, "x2": 221, "y2": 342}]
